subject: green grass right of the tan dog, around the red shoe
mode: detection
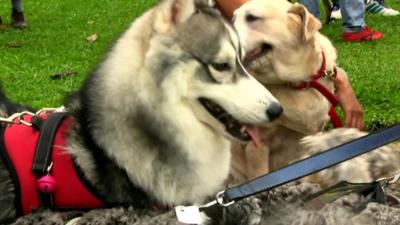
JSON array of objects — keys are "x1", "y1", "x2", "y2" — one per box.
[{"x1": 322, "y1": 0, "x2": 400, "y2": 130}]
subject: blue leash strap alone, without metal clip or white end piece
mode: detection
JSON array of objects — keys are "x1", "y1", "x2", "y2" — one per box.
[{"x1": 222, "y1": 124, "x2": 400, "y2": 203}]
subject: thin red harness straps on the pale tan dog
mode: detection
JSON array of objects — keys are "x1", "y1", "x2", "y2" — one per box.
[{"x1": 288, "y1": 52, "x2": 342, "y2": 128}]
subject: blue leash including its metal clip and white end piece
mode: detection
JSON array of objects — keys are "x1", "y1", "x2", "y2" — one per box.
[{"x1": 175, "y1": 123, "x2": 400, "y2": 224}]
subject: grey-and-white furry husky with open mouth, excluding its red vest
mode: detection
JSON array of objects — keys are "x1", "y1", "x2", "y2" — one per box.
[{"x1": 0, "y1": 0, "x2": 282, "y2": 222}]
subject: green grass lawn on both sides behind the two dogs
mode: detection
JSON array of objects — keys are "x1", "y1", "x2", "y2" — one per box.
[{"x1": 0, "y1": 0, "x2": 400, "y2": 129}]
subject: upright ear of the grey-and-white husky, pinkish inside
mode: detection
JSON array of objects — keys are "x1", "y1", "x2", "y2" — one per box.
[{"x1": 155, "y1": 0, "x2": 196, "y2": 33}]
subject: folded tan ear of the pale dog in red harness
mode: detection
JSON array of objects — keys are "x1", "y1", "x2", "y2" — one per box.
[{"x1": 288, "y1": 3, "x2": 322, "y2": 41}]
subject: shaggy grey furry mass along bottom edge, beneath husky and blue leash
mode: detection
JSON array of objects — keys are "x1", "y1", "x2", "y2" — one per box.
[{"x1": 10, "y1": 183, "x2": 400, "y2": 225}]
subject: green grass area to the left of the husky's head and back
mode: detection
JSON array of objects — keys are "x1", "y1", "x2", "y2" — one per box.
[{"x1": 0, "y1": 0, "x2": 156, "y2": 108}]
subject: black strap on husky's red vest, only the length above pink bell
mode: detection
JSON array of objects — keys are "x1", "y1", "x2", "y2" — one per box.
[{"x1": 32, "y1": 112, "x2": 69, "y2": 176}]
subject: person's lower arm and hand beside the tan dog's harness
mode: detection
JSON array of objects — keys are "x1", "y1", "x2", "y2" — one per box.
[{"x1": 335, "y1": 72, "x2": 364, "y2": 130}]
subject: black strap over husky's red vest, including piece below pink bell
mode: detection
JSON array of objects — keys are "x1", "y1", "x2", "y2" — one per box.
[{"x1": 31, "y1": 112, "x2": 69, "y2": 208}]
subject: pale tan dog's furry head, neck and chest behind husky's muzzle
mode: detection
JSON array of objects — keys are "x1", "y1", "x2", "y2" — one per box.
[{"x1": 233, "y1": 0, "x2": 336, "y2": 181}]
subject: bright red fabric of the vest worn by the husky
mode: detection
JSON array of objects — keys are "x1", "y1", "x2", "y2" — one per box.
[{"x1": 4, "y1": 116, "x2": 105, "y2": 215}]
